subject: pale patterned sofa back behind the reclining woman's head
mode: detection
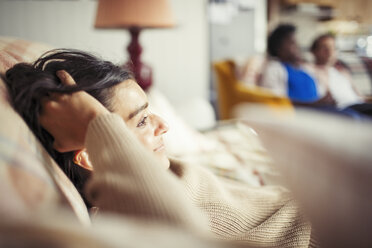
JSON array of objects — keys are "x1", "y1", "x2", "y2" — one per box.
[{"x1": 0, "y1": 37, "x2": 89, "y2": 223}]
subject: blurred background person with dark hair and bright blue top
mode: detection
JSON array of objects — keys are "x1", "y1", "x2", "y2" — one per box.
[{"x1": 261, "y1": 24, "x2": 333, "y2": 104}]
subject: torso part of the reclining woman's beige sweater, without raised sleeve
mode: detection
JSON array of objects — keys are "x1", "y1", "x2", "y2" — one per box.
[{"x1": 171, "y1": 161, "x2": 317, "y2": 247}]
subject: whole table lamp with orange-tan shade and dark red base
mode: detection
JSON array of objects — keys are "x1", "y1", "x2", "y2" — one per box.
[{"x1": 95, "y1": 0, "x2": 174, "y2": 90}]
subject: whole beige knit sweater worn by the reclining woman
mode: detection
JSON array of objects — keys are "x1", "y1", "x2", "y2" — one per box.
[{"x1": 85, "y1": 114, "x2": 313, "y2": 247}]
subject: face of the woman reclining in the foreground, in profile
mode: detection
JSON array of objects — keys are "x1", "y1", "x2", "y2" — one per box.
[{"x1": 112, "y1": 80, "x2": 169, "y2": 168}]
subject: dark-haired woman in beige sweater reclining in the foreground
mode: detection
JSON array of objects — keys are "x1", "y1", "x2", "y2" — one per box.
[{"x1": 5, "y1": 50, "x2": 314, "y2": 247}]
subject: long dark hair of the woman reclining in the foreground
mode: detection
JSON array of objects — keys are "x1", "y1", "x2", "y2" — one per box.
[{"x1": 3, "y1": 49, "x2": 133, "y2": 207}]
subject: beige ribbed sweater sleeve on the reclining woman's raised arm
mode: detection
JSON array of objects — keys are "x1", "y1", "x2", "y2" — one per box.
[{"x1": 85, "y1": 114, "x2": 207, "y2": 232}]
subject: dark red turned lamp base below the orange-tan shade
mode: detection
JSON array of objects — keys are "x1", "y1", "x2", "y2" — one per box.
[{"x1": 127, "y1": 27, "x2": 152, "y2": 91}]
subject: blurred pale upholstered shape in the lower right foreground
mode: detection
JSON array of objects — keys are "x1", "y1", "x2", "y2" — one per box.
[{"x1": 238, "y1": 105, "x2": 372, "y2": 247}]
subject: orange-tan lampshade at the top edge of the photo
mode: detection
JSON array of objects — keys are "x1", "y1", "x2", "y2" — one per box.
[{"x1": 95, "y1": 0, "x2": 174, "y2": 29}]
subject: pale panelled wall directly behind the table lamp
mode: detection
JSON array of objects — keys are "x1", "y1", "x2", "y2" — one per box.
[{"x1": 0, "y1": 0, "x2": 209, "y2": 105}]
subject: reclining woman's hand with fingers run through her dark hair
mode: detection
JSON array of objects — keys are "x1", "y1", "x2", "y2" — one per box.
[{"x1": 39, "y1": 71, "x2": 109, "y2": 152}]
